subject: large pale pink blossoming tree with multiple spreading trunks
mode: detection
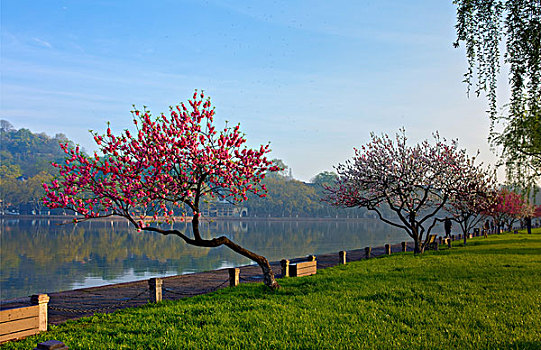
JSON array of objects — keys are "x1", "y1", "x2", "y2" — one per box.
[{"x1": 326, "y1": 129, "x2": 478, "y2": 253}]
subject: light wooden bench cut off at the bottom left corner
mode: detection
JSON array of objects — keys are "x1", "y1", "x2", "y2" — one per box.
[{"x1": 0, "y1": 294, "x2": 49, "y2": 343}]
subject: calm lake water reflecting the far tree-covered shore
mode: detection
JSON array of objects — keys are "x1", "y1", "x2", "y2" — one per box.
[{"x1": 0, "y1": 219, "x2": 410, "y2": 300}]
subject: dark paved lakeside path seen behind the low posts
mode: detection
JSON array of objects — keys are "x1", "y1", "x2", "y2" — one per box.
[{"x1": 0, "y1": 242, "x2": 414, "y2": 324}]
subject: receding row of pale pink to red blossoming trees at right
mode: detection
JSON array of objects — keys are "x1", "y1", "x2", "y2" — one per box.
[{"x1": 326, "y1": 130, "x2": 535, "y2": 253}]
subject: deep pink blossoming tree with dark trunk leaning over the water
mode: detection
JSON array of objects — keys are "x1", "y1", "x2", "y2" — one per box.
[{"x1": 43, "y1": 90, "x2": 280, "y2": 289}]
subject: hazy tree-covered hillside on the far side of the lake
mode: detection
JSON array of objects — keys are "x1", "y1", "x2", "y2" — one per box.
[{"x1": 0, "y1": 120, "x2": 367, "y2": 218}]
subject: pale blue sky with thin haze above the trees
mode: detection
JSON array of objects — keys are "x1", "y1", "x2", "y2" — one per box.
[{"x1": 0, "y1": 0, "x2": 506, "y2": 180}]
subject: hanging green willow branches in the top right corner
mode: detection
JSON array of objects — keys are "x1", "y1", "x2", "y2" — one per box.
[{"x1": 453, "y1": 0, "x2": 541, "y2": 193}]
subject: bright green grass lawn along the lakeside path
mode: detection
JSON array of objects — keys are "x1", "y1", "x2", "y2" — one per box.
[{"x1": 5, "y1": 234, "x2": 541, "y2": 349}]
